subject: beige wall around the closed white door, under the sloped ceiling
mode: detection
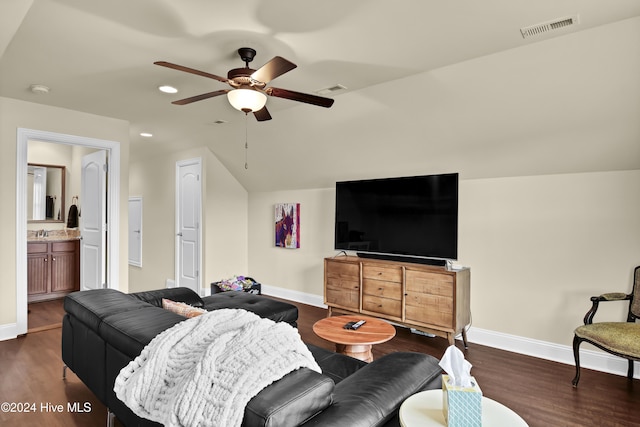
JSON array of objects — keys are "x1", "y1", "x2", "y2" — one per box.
[{"x1": 129, "y1": 148, "x2": 248, "y2": 292}]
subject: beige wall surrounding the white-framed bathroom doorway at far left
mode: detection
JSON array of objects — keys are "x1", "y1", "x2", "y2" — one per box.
[{"x1": 0, "y1": 97, "x2": 129, "y2": 328}]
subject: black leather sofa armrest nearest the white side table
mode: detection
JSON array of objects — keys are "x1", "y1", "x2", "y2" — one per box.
[{"x1": 303, "y1": 352, "x2": 442, "y2": 427}]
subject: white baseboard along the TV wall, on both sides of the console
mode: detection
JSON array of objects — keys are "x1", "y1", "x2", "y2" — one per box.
[{"x1": 262, "y1": 284, "x2": 640, "y2": 379}]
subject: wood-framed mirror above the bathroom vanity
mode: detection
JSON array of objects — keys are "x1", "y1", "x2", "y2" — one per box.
[{"x1": 27, "y1": 163, "x2": 66, "y2": 222}]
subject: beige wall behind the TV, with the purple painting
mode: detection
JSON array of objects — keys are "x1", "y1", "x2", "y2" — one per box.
[{"x1": 249, "y1": 170, "x2": 640, "y2": 345}]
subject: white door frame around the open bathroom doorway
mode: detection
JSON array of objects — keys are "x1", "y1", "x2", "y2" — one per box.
[{"x1": 15, "y1": 128, "x2": 120, "y2": 336}]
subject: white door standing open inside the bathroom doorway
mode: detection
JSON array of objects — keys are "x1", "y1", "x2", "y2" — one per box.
[{"x1": 79, "y1": 150, "x2": 107, "y2": 291}]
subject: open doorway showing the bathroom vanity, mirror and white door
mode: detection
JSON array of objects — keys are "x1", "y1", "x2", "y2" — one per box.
[{"x1": 27, "y1": 140, "x2": 108, "y2": 332}]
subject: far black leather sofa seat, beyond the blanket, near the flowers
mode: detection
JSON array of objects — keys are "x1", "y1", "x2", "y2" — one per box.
[{"x1": 202, "y1": 291, "x2": 298, "y2": 326}]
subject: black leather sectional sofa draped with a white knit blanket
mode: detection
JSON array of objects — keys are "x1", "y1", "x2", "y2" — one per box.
[{"x1": 62, "y1": 288, "x2": 441, "y2": 427}]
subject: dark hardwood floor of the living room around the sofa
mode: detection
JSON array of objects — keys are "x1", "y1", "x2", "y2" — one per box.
[{"x1": 0, "y1": 296, "x2": 640, "y2": 427}]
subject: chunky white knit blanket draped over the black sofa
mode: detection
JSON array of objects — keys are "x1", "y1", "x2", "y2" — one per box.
[{"x1": 114, "y1": 309, "x2": 320, "y2": 427}]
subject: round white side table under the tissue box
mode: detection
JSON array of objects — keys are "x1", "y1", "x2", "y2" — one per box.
[{"x1": 400, "y1": 390, "x2": 527, "y2": 427}]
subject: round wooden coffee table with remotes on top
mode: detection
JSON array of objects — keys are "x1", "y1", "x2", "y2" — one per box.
[{"x1": 313, "y1": 315, "x2": 396, "y2": 362}]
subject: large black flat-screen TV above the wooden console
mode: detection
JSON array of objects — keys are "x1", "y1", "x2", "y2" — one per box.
[{"x1": 335, "y1": 173, "x2": 458, "y2": 260}]
